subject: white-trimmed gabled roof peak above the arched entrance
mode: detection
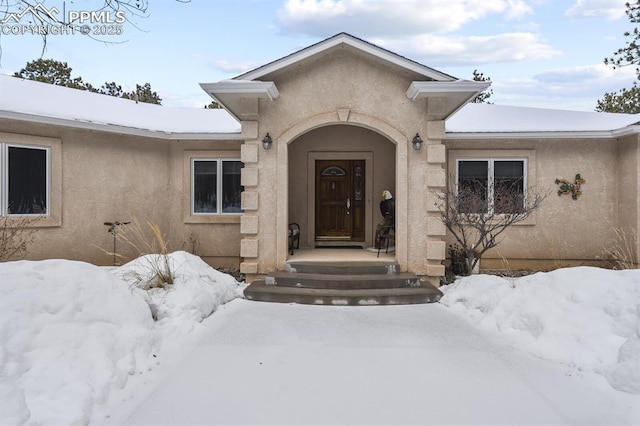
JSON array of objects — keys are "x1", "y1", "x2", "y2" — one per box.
[{"x1": 233, "y1": 32, "x2": 457, "y2": 81}]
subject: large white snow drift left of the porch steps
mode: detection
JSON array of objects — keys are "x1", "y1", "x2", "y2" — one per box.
[{"x1": 0, "y1": 252, "x2": 238, "y2": 425}]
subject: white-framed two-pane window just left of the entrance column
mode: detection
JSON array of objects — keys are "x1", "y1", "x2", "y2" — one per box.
[{"x1": 191, "y1": 158, "x2": 243, "y2": 215}]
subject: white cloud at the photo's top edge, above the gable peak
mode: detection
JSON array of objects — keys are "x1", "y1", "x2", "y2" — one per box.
[{"x1": 278, "y1": 0, "x2": 533, "y2": 37}]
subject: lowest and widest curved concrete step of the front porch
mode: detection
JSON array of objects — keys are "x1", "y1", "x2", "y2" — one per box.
[{"x1": 244, "y1": 280, "x2": 442, "y2": 306}]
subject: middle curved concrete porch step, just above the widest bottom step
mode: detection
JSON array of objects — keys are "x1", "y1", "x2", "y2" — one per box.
[{"x1": 264, "y1": 272, "x2": 420, "y2": 290}]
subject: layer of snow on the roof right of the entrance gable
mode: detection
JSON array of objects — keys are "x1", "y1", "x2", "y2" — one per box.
[{"x1": 445, "y1": 104, "x2": 640, "y2": 136}]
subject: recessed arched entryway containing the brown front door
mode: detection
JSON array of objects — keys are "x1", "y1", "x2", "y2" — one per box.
[{"x1": 288, "y1": 124, "x2": 396, "y2": 248}]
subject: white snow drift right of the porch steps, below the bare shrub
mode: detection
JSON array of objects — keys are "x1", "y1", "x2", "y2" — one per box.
[{"x1": 440, "y1": 267, "x2": 640, "y2": 394}]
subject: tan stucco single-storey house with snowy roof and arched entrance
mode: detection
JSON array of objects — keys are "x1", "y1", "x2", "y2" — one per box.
[{"x1": 0, "y1": 33, "x2": 640, "y2": 285}]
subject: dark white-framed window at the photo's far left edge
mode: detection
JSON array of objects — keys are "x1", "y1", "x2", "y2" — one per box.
[{"x1": 0, "y1": 143, "x2": 51, "y2": 216}]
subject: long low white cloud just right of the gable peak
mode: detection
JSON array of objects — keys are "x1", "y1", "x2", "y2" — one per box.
[{"x1": 373, "y1": 33, "x2": 561, "y2": 66}]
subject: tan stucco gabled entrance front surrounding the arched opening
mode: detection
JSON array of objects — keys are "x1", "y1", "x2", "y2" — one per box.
[{"x1": 241, "y1": 47, "x2": 445, "y2": 276}]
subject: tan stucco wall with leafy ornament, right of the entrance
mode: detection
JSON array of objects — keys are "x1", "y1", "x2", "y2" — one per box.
[{"x1": 446, "y1": 139, "x2": 637, "y2": 269}]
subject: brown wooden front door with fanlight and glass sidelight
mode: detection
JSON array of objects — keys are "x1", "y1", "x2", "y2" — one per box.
[{"x1": 316, "y1": 160, "x2": 365, "y2": 241}]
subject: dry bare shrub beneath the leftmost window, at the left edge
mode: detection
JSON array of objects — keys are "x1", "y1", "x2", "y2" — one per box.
[{"x1": 0, "y1": 216, "x2": 40, "y2": 262}]
